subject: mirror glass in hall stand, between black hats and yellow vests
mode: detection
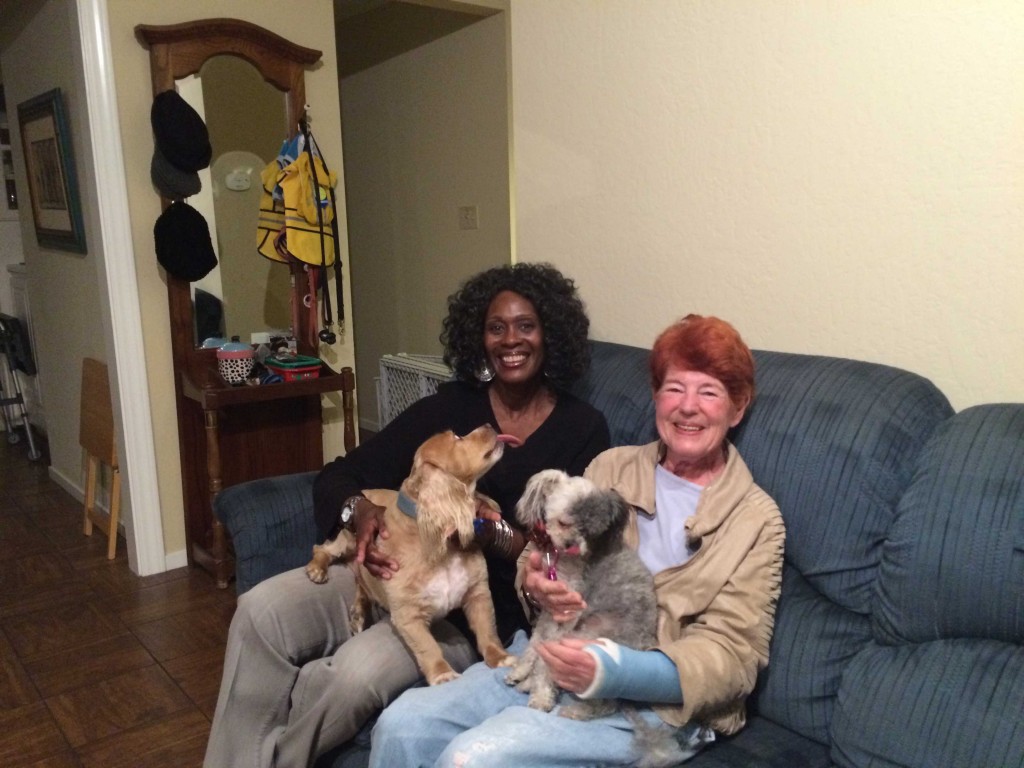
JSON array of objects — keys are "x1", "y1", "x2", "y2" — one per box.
[{"x1": 175, "y1": 55, "x2": 291, "y2": 345}]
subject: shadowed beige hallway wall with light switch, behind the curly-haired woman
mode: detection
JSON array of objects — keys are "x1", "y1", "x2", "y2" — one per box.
[{"x1": 342, "y1": 13, "x2": 511, "y2": 429}]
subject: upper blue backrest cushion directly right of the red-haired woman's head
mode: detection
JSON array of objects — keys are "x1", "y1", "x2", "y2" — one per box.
[{"x1": 734, "y1": 351, "x2": 952, "y2": 615}]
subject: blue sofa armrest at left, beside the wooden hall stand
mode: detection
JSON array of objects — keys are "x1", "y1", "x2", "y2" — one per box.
[{"x1": 213, "y1": 472, "x2": 316, "y2": 595}]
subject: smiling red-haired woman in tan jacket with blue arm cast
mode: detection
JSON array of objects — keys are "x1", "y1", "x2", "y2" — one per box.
[{"x1": 371, "y1": 314, "x2": 785, "y2": 768}]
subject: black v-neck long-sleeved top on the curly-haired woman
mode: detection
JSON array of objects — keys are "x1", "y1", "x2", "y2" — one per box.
[{"x1": 313, "y1": 381, "x2": 610, "y2": 641}]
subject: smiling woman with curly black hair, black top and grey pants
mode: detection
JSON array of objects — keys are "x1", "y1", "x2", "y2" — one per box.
[{"x1": 205, "y1": 264, "x2": 610, "y2": 768}]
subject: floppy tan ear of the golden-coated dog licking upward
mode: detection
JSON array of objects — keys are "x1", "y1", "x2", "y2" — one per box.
[{"x1": 416, "y1": 464, "x2": 476, "y2": 554}]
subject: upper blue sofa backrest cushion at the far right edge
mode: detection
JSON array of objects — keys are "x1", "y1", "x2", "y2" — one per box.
[{"x1": 874, "y1": 404, "x2": 1024, "y2": 644}]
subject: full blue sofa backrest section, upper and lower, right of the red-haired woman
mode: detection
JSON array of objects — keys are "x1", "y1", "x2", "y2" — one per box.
[{"x1": 732, "y1": 351, "x2": 952, "y2": 742}]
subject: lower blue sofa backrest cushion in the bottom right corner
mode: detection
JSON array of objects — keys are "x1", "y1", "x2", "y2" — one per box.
[{"x1": 831, "y1": 638, "x2": 1024, "y2": 768}]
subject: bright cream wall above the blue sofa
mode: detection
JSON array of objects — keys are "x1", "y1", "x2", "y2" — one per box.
[{"x1": 511, "y1": 0, "x2": 1024, "y2": 410}]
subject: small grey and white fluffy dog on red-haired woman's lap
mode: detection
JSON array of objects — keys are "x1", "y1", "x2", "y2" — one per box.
[{"x1": 505, "y1": 469, "x2": 657, "y2": 720}]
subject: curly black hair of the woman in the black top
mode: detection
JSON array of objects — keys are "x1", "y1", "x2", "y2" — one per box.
[{"x1": 440, "y1": 263, "x2": 590, "y2": 389}]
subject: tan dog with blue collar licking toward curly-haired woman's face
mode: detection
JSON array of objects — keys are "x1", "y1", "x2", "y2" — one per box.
[{"x1": 306, "y1": 424, "x2": 515, "y2": 685}]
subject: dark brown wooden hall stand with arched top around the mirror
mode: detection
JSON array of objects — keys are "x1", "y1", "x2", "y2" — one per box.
[{"x1": 135, "y1": 18, "x2": 355, "y2": 587}]
